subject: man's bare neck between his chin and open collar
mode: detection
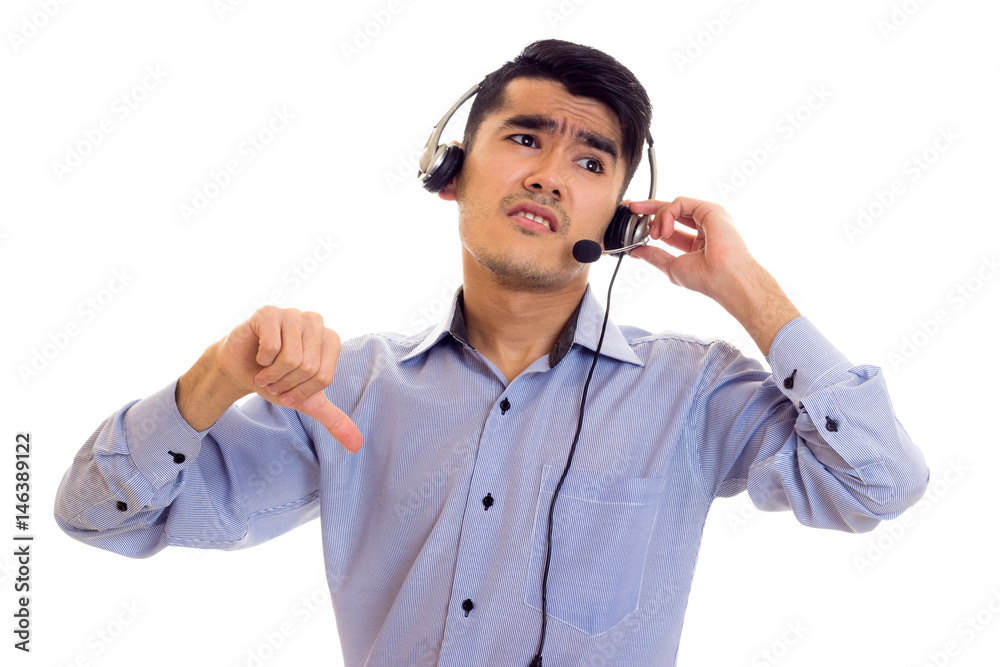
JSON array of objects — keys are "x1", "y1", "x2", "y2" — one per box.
[{"x1": 462, "y1": 253, "x2": 587, "y2": 382}]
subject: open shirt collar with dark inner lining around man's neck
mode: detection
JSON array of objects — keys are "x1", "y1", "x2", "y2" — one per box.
[{"x1": 402, "y1": 284, "x2": 643, "y2": 368}]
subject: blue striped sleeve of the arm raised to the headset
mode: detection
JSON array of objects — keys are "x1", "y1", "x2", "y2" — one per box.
[{"x1": 686, "y1": 316, "x2": 930, "y2": 532}]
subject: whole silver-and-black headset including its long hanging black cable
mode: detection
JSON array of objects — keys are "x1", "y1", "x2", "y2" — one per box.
[{"x1": 417, "y1": 79, "x2": 656, "y2": 667}]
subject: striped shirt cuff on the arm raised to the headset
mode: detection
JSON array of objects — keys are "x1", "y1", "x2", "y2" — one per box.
[{"x1": 766, "y1": 315, "x2": 853, "y2": 411}]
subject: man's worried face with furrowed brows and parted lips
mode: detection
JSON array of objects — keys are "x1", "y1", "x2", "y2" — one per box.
[{"x1": 440, "y1": 78, "x2": 625, "y2": 291}]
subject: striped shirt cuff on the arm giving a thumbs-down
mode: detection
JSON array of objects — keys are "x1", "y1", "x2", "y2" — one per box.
[{"x1": 125, "y1": 380, "x2": 208, "y2": 489}]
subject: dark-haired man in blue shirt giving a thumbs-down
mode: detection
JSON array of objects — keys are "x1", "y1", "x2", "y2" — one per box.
[{"x1": 56, "y1": 40, "x2": 929, "y2": 666}]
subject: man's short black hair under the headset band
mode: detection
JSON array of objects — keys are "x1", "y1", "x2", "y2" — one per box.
[{"x1": 462, "y1": 39, "x2": 653, "y2": 199}]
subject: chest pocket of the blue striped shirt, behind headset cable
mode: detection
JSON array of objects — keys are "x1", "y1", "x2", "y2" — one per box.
[{"x1": 524, "y1": 465, "x2": 664, "y2": 636}]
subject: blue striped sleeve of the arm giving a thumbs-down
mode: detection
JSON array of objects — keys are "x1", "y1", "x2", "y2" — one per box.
[{"x1": 55, "y1": 380, "x2": 319, "y2": 558}]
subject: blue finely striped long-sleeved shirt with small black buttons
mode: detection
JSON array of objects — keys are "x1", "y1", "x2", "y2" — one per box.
[{"x1": 56, "y1": 288, "x2": 929, "y2": 667}]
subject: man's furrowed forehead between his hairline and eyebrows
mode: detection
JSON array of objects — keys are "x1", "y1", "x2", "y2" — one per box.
[{"x1": 486, "y1": 77, "x2": 622, "y2": 154}]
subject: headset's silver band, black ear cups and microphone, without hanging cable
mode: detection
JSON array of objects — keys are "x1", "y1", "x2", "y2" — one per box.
[{"x1": 417, "y1": 79, "x2": 656, "y2": 263}]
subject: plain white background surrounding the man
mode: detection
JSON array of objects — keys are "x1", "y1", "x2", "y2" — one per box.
[{"x1": 0, "y1": 0, "x2": 1000, "y2": 667}]
